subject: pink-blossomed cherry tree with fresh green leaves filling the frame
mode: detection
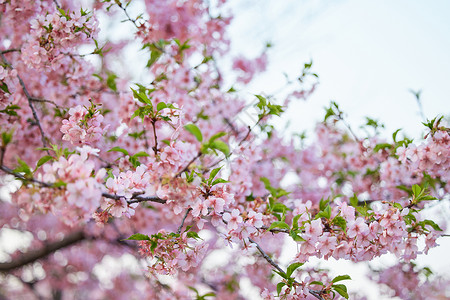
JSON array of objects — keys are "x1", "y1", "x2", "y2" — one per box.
[{"x1": 0, "y1": 0, "x2": 450, "y2": 299}]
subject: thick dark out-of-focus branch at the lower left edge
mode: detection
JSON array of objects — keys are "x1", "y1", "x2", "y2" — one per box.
[{"x1": 0, "y1": 231, "x2": 86, "y2": 272}]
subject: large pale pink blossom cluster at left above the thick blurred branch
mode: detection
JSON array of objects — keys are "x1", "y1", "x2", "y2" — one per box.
[{"x1": 15, "y1": 146, "x2": 106, "y2": 226}]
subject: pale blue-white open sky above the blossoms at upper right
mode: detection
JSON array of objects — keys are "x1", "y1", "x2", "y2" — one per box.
[{"x1": 230, "y1": 0, "x2": 450, "y2": 138}]
